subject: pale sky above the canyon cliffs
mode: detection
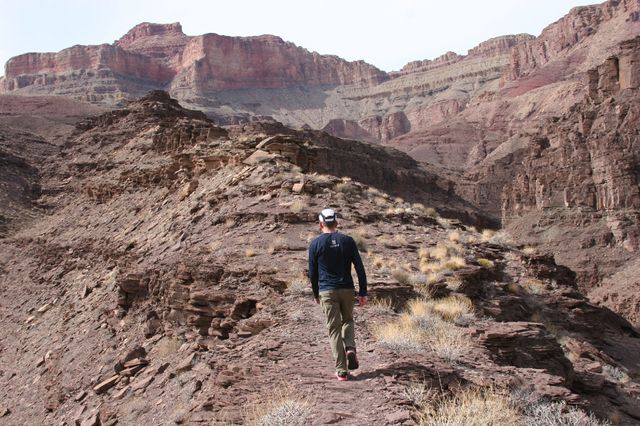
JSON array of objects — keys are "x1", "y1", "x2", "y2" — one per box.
[{"x1": 0, "y1": 0, "x2": 593, "y2": 74}]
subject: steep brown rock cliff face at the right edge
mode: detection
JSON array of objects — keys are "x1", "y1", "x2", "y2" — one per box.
[{"x1": 502, "y1": 37, "x2": 640, "y2": 322}]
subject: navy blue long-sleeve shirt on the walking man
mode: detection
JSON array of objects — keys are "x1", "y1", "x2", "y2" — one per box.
[{"x1": 309, "y1": 232, "x2": 367, "y2": 298}]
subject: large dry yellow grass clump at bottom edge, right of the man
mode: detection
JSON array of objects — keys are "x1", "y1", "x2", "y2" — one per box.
[{"x1": 419, "y1": 388, "x2": 520, "y2": 426}]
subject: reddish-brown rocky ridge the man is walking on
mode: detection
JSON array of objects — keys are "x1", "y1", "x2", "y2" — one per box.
[{"x1": 0, "y1": 92, "x2": 640, "y2": 425}]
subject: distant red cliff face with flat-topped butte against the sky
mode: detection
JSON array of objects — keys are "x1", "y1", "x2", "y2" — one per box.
[{"x1": 3, "y1": 23, "x2": 387, "y2": 98}]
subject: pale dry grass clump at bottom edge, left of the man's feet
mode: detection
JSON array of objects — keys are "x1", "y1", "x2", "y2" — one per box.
[{"x1": 247, "y1": 388, "x2": 311, "y2": 426}]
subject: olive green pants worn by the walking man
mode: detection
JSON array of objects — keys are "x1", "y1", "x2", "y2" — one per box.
[{"x1": 320, "y1": 289, "x2": 356, "y2": 373}]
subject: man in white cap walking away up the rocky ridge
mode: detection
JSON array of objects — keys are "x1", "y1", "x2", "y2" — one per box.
[{"x1": 309, "y1": 209, "x2": 367, "y2": 381}]
